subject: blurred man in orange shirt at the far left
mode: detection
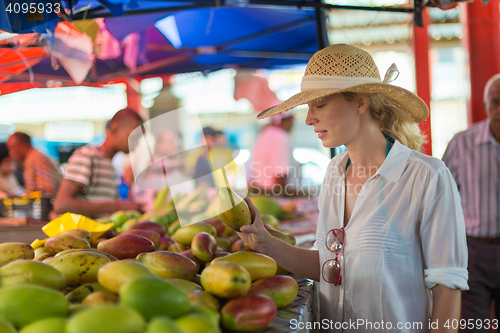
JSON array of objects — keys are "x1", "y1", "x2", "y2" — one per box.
[{"x1": 7, "y1": 132, "x2": 61, "y2": 196}]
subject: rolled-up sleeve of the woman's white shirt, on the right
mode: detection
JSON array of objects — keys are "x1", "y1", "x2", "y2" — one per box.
[{"x1": 420, "y1": 165, "x2": 468, "y2": 290}]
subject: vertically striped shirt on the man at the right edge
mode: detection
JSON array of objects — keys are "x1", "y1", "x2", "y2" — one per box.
[{"x1": 443, "y1": 120, "x2": 500, "y2": 238}]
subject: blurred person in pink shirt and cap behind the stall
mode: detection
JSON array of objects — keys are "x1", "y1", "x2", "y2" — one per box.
[{"x1": 250, "y1": 113, "x2": 294, "y2": 194}]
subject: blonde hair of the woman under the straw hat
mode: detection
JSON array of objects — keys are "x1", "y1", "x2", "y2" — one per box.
[{"x1": 342, "y1": 92, "x2": 425, "y2": 151}]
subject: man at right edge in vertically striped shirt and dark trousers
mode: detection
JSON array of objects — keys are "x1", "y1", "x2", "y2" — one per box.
[{"x1": 443, "y1": 74, "x2": 500, "y2": 331}]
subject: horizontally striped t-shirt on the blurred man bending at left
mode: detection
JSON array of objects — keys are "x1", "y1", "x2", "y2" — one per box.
[{"x1": 64, "y1": 146, "x2": 118, "y2": 202}]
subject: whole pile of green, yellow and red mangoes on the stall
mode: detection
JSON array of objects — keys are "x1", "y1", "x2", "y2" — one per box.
[{"x1": 0, "y1": 193, "x2": 298, "y2": 333}]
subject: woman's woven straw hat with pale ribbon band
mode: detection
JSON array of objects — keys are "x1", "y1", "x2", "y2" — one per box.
[{"x1": 257, "y1": 44, "x2": 429, "y2": 123}]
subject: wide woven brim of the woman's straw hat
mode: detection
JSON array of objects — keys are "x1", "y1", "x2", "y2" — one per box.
[{"x1": 257, "y1": 83, "x2": 429, "y2": 123}]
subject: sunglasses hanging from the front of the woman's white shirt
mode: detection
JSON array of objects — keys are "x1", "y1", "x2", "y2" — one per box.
[{"x1": 321, "y1": 228, "x2": 344, "y2": 286}]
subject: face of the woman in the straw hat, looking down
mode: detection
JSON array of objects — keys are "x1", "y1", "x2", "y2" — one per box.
[{"x1": 306, "y1": 94, "x2": 359, "y2": 148}]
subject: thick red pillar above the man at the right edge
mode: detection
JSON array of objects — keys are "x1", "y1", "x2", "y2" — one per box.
[{"x1": 460, "y1": 0, "x2": 500, "y2": 125}]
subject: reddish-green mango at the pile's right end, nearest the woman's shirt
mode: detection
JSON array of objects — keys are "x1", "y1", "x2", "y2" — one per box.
[{"x1": 248, "y1": 275, "x2": 299, "y2": 308}]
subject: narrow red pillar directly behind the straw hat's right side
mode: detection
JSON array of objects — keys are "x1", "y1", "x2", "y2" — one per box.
[{"x1": 413, "y1": 9, "x2": 432, "y2": 155}]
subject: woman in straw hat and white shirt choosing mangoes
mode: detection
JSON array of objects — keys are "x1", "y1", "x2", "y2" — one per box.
[{"x1": 239, "y1": 44, "x2": 468, "y2": 332}]
